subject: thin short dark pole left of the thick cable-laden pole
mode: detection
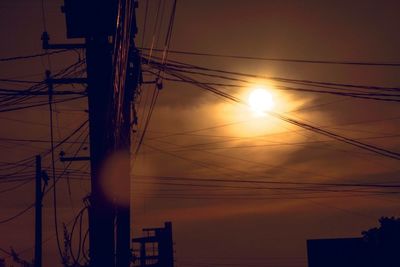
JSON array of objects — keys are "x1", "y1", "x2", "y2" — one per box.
[{"x1": 35, "y1": 155, "x2": 43, "y2": 267}]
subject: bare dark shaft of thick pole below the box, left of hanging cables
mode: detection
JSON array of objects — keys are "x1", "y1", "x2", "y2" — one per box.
[{"x1": 86, "y1": 31, "x2": 115, "y2": 267}]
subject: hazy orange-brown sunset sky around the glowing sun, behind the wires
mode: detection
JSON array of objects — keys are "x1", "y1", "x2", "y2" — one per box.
[{"x1": 0, "y1": 0, "x2": 400, "y2": 267}]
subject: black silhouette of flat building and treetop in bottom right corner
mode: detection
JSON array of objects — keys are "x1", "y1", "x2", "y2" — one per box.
[{"x1": 307, "y1": 217, "x2": 400, "y2": 267}]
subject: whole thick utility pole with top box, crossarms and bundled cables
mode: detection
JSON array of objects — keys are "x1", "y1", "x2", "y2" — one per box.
[{"x1": 42, "y1": 0, "x2": 141, "y2": 267}]
